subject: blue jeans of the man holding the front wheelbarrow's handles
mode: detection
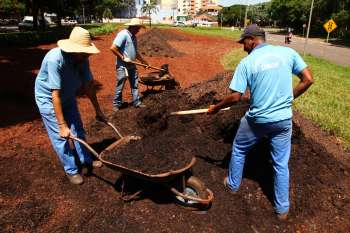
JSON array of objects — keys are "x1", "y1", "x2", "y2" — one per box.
[{"x1": 39, "y1": 104, "x2": 92, "y2": 175}]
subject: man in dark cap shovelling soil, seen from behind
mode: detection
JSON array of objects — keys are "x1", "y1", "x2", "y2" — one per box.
[{"x1": 208, "y1": 24, "x2": 313, "y2": 220}]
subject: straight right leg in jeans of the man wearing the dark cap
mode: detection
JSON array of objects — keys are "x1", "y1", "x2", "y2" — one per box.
[{"x1": 269, "y1": 119, "x2": 292, "y2": 214}]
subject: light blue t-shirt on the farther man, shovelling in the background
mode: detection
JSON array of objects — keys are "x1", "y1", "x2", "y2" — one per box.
[{"x1": 113, "y1": 29, "x2": 137, "y2": 67}]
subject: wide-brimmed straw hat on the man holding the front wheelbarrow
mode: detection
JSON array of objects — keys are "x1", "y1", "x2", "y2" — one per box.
[{"x1": 57, "y1": 27, "x2": 100, "y2": 54}]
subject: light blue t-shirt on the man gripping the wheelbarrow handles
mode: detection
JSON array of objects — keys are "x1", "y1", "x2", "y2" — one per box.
[{"x1": 35, "y1": 48, "x2": 92, "y2": 112}]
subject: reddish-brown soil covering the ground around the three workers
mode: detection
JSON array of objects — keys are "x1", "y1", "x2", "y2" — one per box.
[{"x1": 0, "y1": 27, "x2": 350, "y2": 233}]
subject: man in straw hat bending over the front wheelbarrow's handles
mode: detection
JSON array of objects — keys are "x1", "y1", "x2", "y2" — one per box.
[{"x1": 35, "y1": 27, "x2": 106, "y2": 184}]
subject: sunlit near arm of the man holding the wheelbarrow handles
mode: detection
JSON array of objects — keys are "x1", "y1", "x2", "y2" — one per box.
[{"x1": 51, "y1": 89, "x2": 70, "y2": 138}]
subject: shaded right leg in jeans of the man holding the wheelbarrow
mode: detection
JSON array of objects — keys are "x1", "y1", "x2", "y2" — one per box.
[{"x1": 63, "y1": 103, "x2": 92, "y2": 165}]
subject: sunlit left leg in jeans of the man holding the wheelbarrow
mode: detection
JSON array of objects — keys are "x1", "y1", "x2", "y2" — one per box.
[{"x1": 41, "y1": 109, "x2": 78, "y2": 175}]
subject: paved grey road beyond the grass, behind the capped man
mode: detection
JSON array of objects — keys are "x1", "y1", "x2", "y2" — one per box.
[{"x1": 266, "y1": 33, "x2": 350, "y2": 67}]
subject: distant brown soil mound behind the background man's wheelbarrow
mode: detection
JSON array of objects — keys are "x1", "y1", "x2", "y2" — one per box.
[{"x1": 138, "y1": 28, "x2": 184, "y2": 58}]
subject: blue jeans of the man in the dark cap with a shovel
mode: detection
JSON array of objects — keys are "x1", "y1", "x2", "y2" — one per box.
[{"x1": 228, "y1": 117, "x2": 292, "y2": 214}]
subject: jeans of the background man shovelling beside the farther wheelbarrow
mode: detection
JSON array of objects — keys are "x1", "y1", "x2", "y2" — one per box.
[{"x1": 113, "y1": 66, "x2": 141, "y2": 107}]
